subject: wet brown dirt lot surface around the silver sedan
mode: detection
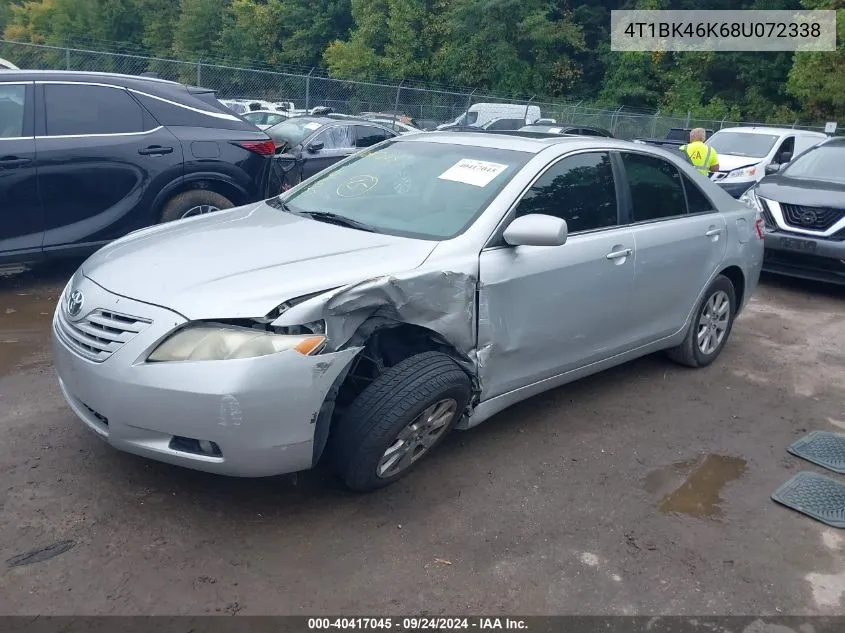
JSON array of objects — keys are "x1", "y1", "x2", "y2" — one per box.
[{"x1": 0, "y1": 266, "x2": 845, "y2": 615}]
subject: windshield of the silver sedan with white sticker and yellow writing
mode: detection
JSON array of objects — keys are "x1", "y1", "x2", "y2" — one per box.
[{"x1": 284, "y1": 140, "x2": 532, "y2": 240}]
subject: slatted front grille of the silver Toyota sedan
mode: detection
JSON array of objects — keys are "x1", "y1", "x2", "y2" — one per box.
[{"x1": 56, "y1": 308, "x2": 152, "y2": 363}]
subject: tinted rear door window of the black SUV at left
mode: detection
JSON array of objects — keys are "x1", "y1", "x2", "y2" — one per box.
[{"x1": 44, "y1": 84, "x2": 144, "y2": 136}]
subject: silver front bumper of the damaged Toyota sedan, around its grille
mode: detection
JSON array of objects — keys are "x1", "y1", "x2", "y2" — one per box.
[{"x1": 52, "y1": 275, "x2": 358, "y2": 477}]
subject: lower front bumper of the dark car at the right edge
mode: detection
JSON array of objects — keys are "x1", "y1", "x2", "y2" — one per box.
[{"x1": 763, "y1": 231, "x2": 845, "y2": 284}]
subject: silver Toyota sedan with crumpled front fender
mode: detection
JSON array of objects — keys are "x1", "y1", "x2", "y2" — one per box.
[{"x1": 53, "y1": 132, "x2": 763, "y2": 490}]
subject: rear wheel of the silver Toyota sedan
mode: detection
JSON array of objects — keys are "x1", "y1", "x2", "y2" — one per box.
[{"x1": 667, "y1": 275, "x2": 736, "y2": 367}]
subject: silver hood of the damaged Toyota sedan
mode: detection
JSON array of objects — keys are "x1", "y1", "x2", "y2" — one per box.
[{"x1": 82, "y1": 203, "x2": 437, "y2": 319}]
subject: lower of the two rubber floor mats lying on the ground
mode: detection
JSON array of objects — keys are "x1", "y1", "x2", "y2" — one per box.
[{"x1": 772, "y1": 471, "x2": 845, "y2": 528}]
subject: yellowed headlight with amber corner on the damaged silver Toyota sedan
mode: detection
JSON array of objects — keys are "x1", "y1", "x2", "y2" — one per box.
[{"x1": 147, "y1": 325, "x2": 326, "y2": 362}]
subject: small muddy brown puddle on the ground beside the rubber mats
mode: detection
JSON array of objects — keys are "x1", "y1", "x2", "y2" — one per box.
[{"x1": 644, "y1": 455, "x2": 746, "y2": 517}]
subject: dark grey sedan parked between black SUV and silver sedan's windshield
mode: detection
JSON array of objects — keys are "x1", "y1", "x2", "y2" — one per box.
[{"x1": 265, "y1": 116, "x2": 397, "y2": 190}]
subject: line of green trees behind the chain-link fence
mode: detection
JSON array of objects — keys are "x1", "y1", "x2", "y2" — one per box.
[{"x1": 0, "y1": 0, "x2": 845, "y2": 122}]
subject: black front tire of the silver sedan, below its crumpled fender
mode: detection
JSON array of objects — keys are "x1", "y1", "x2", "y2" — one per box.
[{"x1": 330, "y1": 352, "x2": 472, "y2": 492}]
